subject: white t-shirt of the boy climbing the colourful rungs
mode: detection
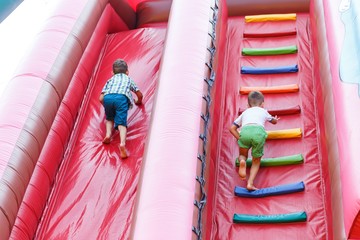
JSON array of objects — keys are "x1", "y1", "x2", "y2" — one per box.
[{"x1": 234, "y1": 107, "x2": 273, "y2": 127}]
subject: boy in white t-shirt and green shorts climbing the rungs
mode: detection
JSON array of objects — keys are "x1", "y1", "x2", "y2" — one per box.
[{"x1": 229, "y1": 91, "x2": 280, "y2": 191}]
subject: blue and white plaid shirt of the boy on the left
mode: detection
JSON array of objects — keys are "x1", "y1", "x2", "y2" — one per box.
[{"x1": 101, "y1": 73, "x2": 139, "y2": 107}]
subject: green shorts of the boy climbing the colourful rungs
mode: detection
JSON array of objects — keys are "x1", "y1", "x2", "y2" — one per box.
[{"x1": 238, "y1": 125, "x2": 267, "y2": 157}]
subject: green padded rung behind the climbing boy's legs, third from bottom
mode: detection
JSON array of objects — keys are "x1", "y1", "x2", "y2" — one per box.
[{"x1": 235, "y1": 154, "x2": 304, "y2": 167}]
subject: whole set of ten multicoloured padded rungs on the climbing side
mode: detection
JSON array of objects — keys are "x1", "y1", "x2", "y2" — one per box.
[{"x1": 233, "y1": 14, "x2": 307, "y2": 223}]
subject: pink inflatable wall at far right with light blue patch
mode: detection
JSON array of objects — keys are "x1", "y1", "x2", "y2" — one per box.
[{"x1": 322, "y1": 0, "x2": 360, "y2": 239}]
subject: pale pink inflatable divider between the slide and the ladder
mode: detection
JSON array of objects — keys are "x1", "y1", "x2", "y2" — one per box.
[{"x1": 132, "y1": 0, "x2": 211, "y2": 240}]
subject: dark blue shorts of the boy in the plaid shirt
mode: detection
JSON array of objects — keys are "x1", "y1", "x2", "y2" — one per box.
[{"x1": 104, "y1": 94, "x2": 129, "y2": 129}]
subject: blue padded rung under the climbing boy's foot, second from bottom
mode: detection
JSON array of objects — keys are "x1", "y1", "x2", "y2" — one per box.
[{"x1": 234, "y1": 182, "x2": 305, "y2": 198}]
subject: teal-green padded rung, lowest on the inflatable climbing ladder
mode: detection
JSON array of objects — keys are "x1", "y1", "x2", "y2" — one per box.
[{"x1": 233, "y1": 212, "x2": 307, "y2": 223}]
